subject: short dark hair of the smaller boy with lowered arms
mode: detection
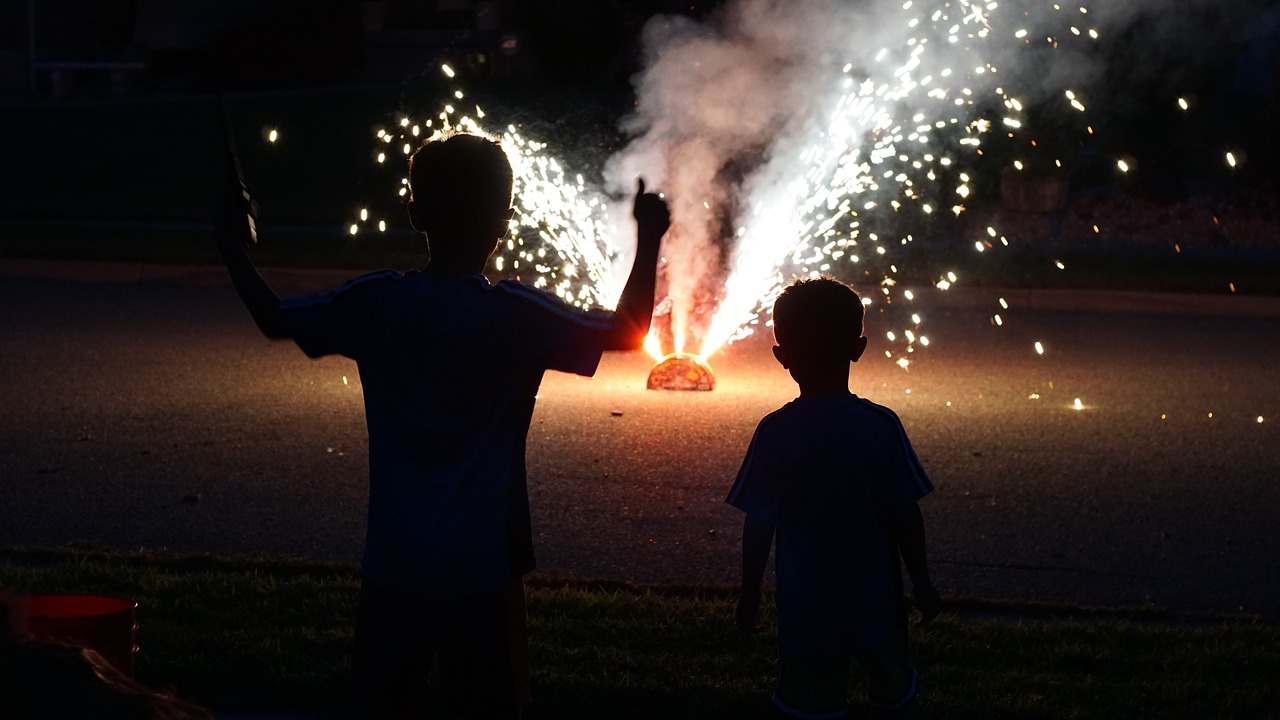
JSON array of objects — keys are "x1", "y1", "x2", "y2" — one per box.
[{"x1": 773, "y1": 275, "x2": 864, "y2": 352}]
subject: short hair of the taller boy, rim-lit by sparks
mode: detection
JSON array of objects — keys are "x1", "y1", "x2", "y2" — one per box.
[{"x1": 408, "y1": 133, "x2": 513, "y2": 225}]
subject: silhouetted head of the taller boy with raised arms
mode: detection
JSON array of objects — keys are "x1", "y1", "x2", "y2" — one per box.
[{"x1": 408, "y1": 133, "x2": 512, "y2": 259}]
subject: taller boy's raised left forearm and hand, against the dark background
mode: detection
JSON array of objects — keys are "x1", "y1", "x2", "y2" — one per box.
[{"x1": 214, "y1": 140, "x2": 289, "y2": 340}]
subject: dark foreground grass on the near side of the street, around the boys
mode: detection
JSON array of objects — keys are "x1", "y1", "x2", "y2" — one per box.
[{"x1": 0, "y1": 548, "x2": 1280, "y2": 720}]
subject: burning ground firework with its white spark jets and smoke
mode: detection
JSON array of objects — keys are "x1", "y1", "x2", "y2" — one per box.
[{"x1": 352, "y1": 0, "x2": 1098, "y2": 388}]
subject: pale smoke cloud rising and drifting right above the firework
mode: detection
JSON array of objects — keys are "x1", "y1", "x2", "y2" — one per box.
[{"x1": 605, "y1": 0, "x2": 1254, "y2": 351}]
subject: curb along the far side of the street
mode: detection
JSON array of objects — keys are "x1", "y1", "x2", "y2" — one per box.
[{"x1": 0, "y1": 259, "x2": 1280, "y2": 318}]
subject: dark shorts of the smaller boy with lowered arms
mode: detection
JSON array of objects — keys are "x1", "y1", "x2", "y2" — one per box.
[{"x1": 773, "y1": 628, "x2": 919, "y2": 720}]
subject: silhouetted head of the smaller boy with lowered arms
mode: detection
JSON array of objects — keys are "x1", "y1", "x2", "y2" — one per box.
[{"x1": 773, "y1": 277, "x2": 867, "y2": 384}]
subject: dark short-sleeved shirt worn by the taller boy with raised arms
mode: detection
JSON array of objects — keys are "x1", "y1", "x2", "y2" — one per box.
[{"x1": 280, "y1": 270, "x2": 613, "y2": 597}]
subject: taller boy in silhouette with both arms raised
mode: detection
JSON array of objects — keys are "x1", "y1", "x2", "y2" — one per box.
[{"x1": 218, "y1": 133, "x2": 669, "y2": 717}]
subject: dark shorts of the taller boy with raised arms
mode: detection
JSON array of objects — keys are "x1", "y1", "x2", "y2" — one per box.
[{"x1": 352, "y1": 579, "x2": 530, "y2": 717}]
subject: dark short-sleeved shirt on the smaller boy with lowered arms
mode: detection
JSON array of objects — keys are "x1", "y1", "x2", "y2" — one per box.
[{"x1": 727, "y1": 395, "x2": 933, "y2": 655}]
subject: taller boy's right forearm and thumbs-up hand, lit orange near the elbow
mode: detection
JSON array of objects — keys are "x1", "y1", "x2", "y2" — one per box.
[{"x1": 604, "y1": 179, "x2": 671, "y2": 350}]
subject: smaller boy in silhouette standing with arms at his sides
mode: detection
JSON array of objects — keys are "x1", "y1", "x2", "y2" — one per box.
[{"x1": 727, "y1": 277, "x2": 941, "y2": 719}]
